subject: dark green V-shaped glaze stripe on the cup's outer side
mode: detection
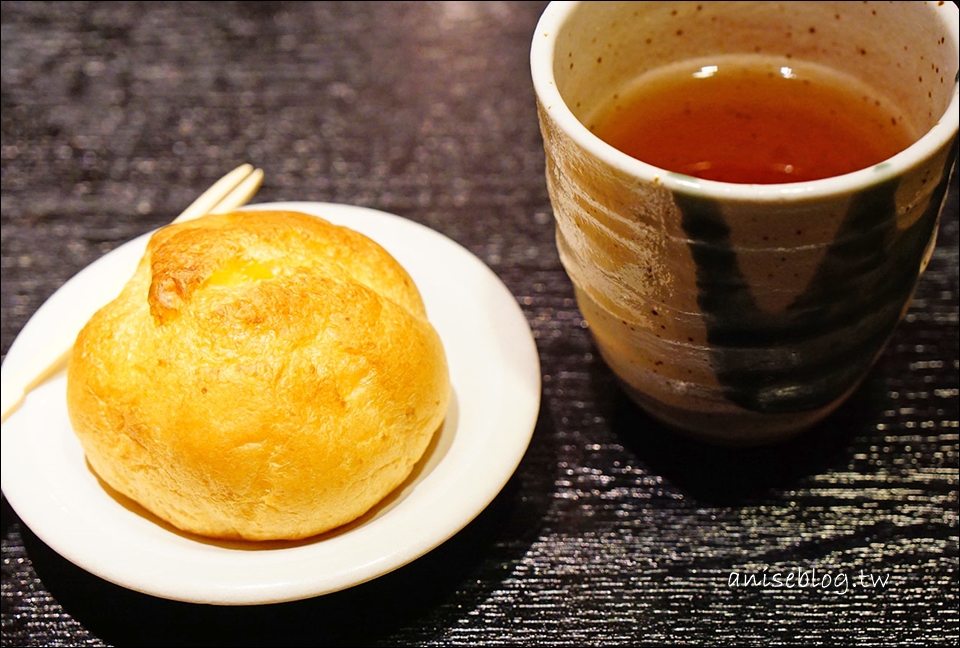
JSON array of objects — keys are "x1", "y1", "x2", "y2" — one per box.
[{"x1": 674, "y1": 137, "x2": 956, "y2": 414}]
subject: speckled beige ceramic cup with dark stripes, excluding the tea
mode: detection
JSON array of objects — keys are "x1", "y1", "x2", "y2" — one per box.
[{"x1": 530, "y1": 2, "x2": 960, "y2": 443}]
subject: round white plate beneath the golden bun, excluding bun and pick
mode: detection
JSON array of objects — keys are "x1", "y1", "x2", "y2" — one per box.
[{"x1": 0, "y1": 202, "x2": 540, "y2": 605}]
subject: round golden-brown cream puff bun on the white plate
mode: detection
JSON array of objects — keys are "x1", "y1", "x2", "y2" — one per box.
[{"x1": 67, "y1": 211, "x2": 450, "y2": 540}]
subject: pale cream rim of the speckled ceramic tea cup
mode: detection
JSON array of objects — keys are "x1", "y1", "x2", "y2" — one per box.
[{"x1": 530, "y1": 0, "x2": 960, "y2": 202}]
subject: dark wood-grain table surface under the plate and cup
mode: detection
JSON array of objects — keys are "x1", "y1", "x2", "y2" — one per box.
[{"x1": 2, "y1": 2, "x2": 960, "y2": 646}]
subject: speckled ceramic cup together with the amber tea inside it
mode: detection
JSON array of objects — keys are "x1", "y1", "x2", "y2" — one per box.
[{"x1": 531, "y1": 2, "x2": 960, "y2": 443}]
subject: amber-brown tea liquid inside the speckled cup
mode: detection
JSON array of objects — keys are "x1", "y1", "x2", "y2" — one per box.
[{"x1": 589, "y1": 56, "x2": 916, "y2": 184}]
